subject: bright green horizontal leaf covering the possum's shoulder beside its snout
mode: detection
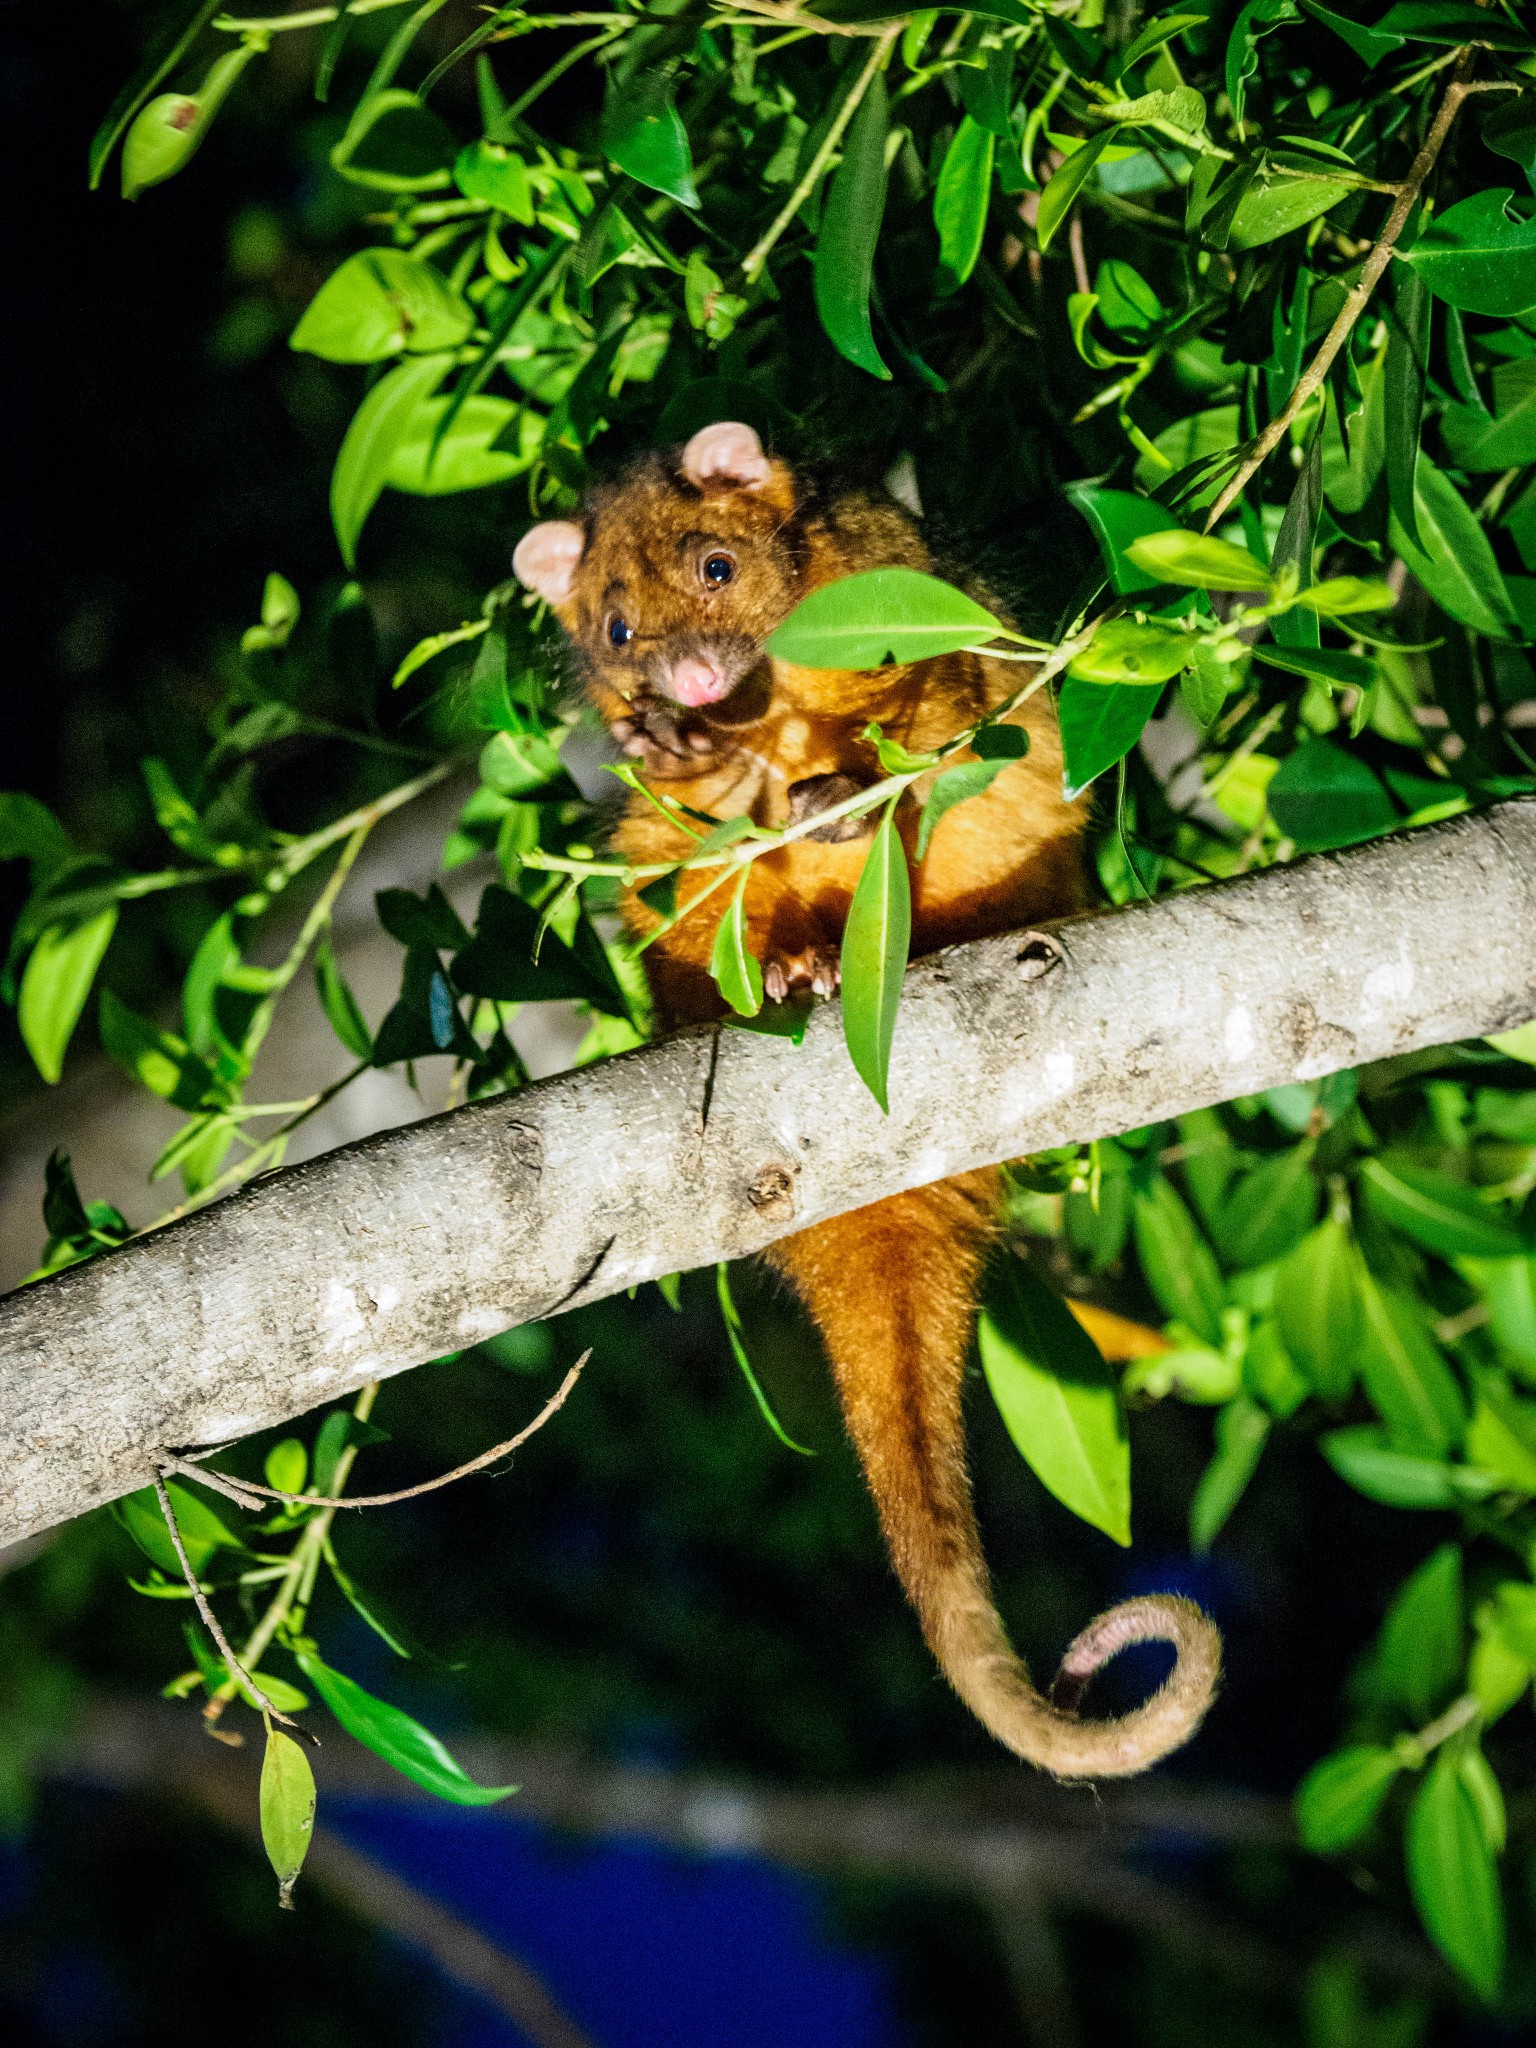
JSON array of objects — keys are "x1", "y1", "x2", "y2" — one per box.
[{"x1": 768, "y1": 569, "x2": 1004, "y2": 668}]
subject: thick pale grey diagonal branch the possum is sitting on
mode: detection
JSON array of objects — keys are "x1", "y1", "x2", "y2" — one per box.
[{"x1": 0, "y1": 801, "x2": 1536, "y2": 1542}]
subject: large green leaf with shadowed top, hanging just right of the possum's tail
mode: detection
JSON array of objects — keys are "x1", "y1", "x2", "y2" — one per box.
[{"x1": 979, "y1": 1257, "x2": 1130, "y2": 1544}]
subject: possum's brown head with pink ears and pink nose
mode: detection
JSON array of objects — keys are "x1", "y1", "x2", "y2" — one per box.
[{"x1": 512, "y1": 420, "x2": 803, "y2": 715}]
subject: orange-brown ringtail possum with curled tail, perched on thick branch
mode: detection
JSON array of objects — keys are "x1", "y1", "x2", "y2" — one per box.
[{"x1": 512, "y1": 422, "x2": 1221, "y2": 1778}]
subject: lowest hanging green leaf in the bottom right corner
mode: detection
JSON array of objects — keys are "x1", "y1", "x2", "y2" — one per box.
[{"x1": 1405, "y1": 1749, "x2": 1503, "y2": 1999}]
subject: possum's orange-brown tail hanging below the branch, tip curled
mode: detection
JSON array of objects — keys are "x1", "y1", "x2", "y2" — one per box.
[{"x1": 768, "y1": 1171, "x2": 1221, "y2": 1778}]
